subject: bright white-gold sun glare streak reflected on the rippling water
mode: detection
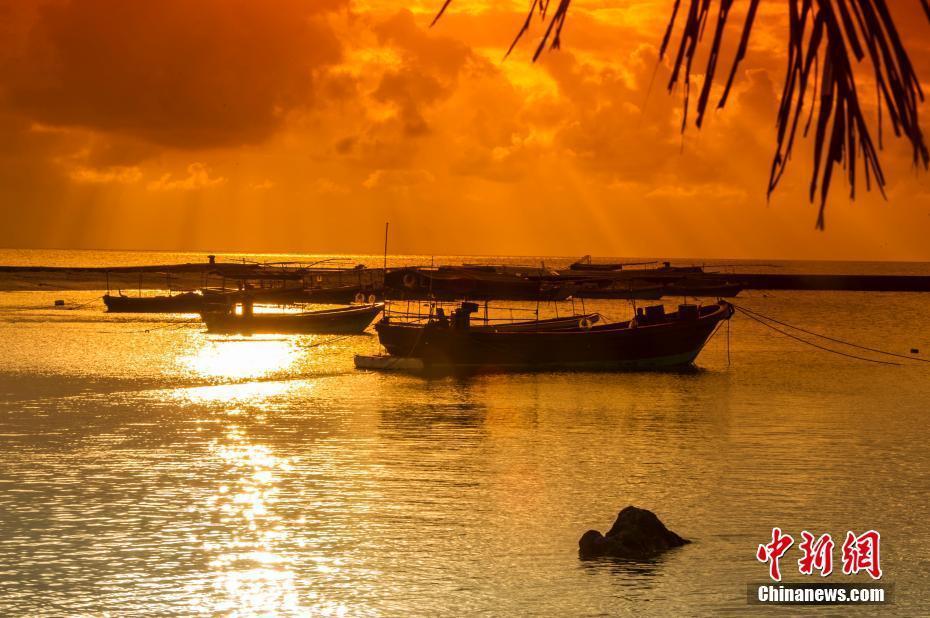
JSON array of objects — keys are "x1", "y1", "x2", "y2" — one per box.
[{"x1": 171, "y1": 328, "x2": 356, "y2": 616}]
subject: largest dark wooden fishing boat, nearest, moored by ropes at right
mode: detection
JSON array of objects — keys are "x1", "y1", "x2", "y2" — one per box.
[{"x1": 362, "y1": 301, "x2": 734, "y2": 371}]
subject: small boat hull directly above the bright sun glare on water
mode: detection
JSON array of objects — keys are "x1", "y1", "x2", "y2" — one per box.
[{"x1": 201, "y1": 303, "x2": 384, "y2": 335}]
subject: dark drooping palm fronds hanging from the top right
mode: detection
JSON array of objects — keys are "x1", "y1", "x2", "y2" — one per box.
[{"x1": 434, "y1": 0, "x2": 930, "y2": 228}]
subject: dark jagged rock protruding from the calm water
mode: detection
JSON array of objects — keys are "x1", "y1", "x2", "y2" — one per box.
[{"x1": 578, "y1": 506, "x2": 691, "y2": 560}]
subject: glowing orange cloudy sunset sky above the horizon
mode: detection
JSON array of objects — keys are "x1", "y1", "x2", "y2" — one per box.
[{"x1": 0, "y1": 0, "x2": 930, "y2": 260}]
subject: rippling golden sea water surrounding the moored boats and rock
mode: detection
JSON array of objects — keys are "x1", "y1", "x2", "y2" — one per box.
[{"x1": 0, "y1": 251, "x2": 930, "y2": 616}]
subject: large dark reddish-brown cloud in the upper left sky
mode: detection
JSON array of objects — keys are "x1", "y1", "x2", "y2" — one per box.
[{"x1": 0, "y1": 0, "x2": 346, "y2": 148}]
